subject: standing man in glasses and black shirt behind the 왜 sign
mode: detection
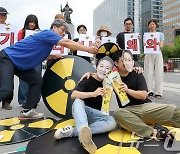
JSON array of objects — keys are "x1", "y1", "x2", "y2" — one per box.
[{"x1": 116, "y1": 18, "x2": 138, "y2": 66}]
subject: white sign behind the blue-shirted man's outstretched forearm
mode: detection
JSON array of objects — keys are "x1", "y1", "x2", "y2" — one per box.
[{"x1": 77, "y1": 34, "x2": 95, "y2": 57}]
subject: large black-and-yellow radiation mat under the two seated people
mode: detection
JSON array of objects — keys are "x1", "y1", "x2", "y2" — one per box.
[{"x1": 26, "y1": 119, "x2": 180, "y2": 154}]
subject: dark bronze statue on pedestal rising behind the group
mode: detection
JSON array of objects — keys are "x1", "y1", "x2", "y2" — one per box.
[{"x1": 61, "y1": 2, "x2": 73, "y2": 24}]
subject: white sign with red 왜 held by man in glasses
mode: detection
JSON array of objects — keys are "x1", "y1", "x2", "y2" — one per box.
[{"x1": 124, "y1": 33, "x2": 140, "y2": 55}]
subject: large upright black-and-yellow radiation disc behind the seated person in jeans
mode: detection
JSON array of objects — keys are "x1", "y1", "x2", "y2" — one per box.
[{"x1": 42, "y1": 55, "x2": 95, "y2": 118}]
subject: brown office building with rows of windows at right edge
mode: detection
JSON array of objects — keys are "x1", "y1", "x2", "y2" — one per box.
[{"x1": 163, "y1": 0, "x2": 180, "y2": 46}]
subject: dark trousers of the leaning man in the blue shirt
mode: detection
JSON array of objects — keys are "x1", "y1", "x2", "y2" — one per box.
[{"x1": 0, "y1": 50, "x2": 43, "y2": 109}]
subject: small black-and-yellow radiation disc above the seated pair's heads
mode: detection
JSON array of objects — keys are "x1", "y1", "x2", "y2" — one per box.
[{"x1": 96, "y1": 42, "x2": 118, "y2": 59}]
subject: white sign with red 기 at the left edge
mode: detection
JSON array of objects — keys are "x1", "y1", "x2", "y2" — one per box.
[{"x1": 0, "y1": 24, "x2": 18, "y2": 50}]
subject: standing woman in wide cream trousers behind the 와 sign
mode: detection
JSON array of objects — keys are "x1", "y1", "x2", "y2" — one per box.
[{"x1": 144, "y1": 19, "x2": 164, "y2": 99}]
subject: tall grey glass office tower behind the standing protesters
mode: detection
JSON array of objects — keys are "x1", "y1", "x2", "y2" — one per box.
[{"x1": 93, "y1": 0, "x2": 165, "y2": 36}]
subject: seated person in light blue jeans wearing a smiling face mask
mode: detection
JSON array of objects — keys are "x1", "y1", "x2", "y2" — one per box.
[{"x1": 54, "y1": 57, "x2": 116, "y2": 153}]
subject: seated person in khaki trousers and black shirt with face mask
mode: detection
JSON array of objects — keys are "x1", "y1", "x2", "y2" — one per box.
[{"x1": 112, "y1": 50, "x2": 180, "y2": 139}]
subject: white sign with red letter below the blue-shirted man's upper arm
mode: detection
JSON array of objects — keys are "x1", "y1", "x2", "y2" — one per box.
[{"x1": 50, "y1": 34, "x2": 70, "y2": 56}]
